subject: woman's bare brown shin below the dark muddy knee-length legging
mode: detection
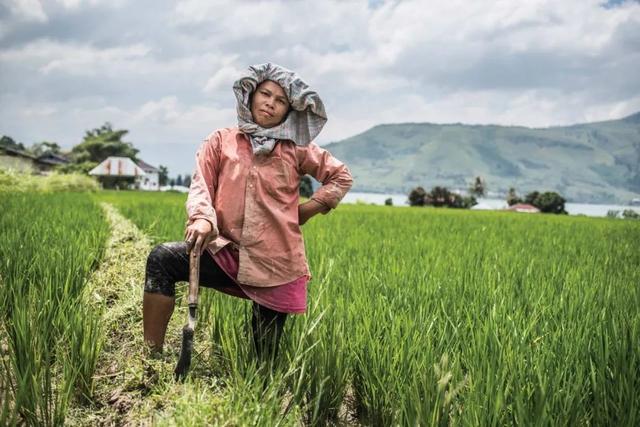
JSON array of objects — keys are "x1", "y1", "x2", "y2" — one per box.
[{"x1": 142, "y1": 292, "x2": 175, "y2": 352}]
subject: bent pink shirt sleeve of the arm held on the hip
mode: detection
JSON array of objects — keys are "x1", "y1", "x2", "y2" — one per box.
[{"x1": 299, "y1": 143, "x2": 353, "y2": 213}]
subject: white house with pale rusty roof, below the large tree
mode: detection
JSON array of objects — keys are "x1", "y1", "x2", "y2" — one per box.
[{"x1": 89, "y1": 156, "x2": 160, "y2": 191}]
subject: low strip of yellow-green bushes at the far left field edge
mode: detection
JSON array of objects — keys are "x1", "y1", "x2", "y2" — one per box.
[{"x1": 0, "y1": 171, "x2": 100, "y2": 193}]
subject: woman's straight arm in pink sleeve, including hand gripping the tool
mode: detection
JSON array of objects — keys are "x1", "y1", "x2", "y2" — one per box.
[{"x1": 185, "y1": 132, "x2": 220, "y2": 254}]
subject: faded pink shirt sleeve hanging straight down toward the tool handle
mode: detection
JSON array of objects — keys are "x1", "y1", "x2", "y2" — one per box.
[{"x1": 186, "y1": 132, "x2": 220, "y2": 229}]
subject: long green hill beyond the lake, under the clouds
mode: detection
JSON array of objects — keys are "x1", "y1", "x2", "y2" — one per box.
[{"x1": 325, "y1": 113, "x2": 640, "y2": 203}]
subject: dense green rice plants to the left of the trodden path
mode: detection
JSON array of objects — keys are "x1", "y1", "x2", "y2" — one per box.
[{"x1": 0, "y1": 193, "x2": 108, "y2": 425}]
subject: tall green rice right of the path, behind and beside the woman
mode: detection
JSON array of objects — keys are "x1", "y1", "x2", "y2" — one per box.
[{"x1": 91, "y1": 193, "x2": 640, "y2": 425}]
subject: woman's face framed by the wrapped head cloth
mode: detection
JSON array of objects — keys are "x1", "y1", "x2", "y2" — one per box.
[{"x1": 251, "y1": 80, "x2": 289, "y2": 128}]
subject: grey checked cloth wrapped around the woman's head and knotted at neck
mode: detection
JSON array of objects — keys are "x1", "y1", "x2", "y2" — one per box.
[{"x1": 233, "y1": 62, "x2": 327, "y2": 154}]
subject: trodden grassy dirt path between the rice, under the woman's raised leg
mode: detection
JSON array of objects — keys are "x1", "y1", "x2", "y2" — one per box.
[{"x1": 65, "y1": 203, "x2": 355, "y2": 426}]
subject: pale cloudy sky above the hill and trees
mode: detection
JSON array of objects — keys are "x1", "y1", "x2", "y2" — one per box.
[{"x1": 0, "y1": 0, "x2": 640, "y2": 173}]
